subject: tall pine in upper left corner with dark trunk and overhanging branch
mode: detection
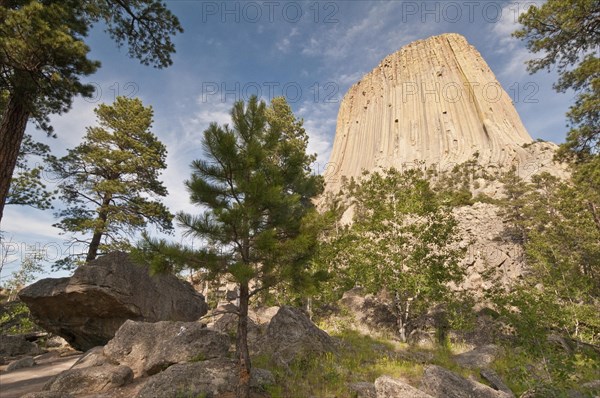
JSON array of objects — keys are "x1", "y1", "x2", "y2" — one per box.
[{"x1": 0, "y1": 0, "x2": 182, "y2": 224}]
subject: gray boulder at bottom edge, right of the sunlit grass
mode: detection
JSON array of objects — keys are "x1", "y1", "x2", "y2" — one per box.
[{"x1": 421, "y1": 365, "x2": 512, "y2": 398}]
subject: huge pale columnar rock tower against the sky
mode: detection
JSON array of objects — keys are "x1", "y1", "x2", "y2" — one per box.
[{"x1": 328, "y1": 34, "x2": 532, "y2": 188}]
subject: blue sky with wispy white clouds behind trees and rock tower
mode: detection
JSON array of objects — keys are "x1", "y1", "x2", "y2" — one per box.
[{"x1": 0, "y1": 0, "x2": 572, "y2": 281}]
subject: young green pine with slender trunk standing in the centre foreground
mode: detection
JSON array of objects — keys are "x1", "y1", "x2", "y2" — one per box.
[{"x1": 137, "y1": 97, "x2": 323, "y2": 398}]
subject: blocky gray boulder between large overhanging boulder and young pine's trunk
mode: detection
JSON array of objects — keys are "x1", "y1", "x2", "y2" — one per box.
[{"x1": 104, "y1": 321, "x2": 229, "y2": 377}]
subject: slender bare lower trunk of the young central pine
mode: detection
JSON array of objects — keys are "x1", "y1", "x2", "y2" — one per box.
[{"x1": 236, "y1": 282, "x2": 251, "y2": 398}]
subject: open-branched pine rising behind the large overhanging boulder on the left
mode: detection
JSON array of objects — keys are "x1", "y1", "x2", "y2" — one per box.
[{"x1": 52, "y1": 97, "x2": 173, "y2": 265}]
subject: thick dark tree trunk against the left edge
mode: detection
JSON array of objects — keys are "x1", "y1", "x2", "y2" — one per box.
[{"x1": 0, "y1": 95, "x2": 29, "y2": 222}]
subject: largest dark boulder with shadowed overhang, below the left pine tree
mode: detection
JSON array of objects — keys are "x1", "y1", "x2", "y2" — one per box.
[{"x1": 19, "y1": 252, "x2": 207, "y2": 351}]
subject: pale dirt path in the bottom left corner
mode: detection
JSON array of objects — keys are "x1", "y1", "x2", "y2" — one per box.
[{"x1": 0, "y1": 353, "x2": 81, "y2": 398}]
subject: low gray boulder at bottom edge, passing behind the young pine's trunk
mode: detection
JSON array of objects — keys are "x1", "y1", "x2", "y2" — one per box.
[{"x1": 136, "y1": 358, "x2": 273, "y2": 398}]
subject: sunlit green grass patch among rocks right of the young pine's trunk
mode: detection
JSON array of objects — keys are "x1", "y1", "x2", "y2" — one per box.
[{"x1": 253, "y1": 330, "x2": 488, "y2": 398}]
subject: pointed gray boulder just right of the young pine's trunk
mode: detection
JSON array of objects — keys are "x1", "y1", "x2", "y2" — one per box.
[{"x1": 259, "y1": 306, "x2": 336, "y2": 366}]
